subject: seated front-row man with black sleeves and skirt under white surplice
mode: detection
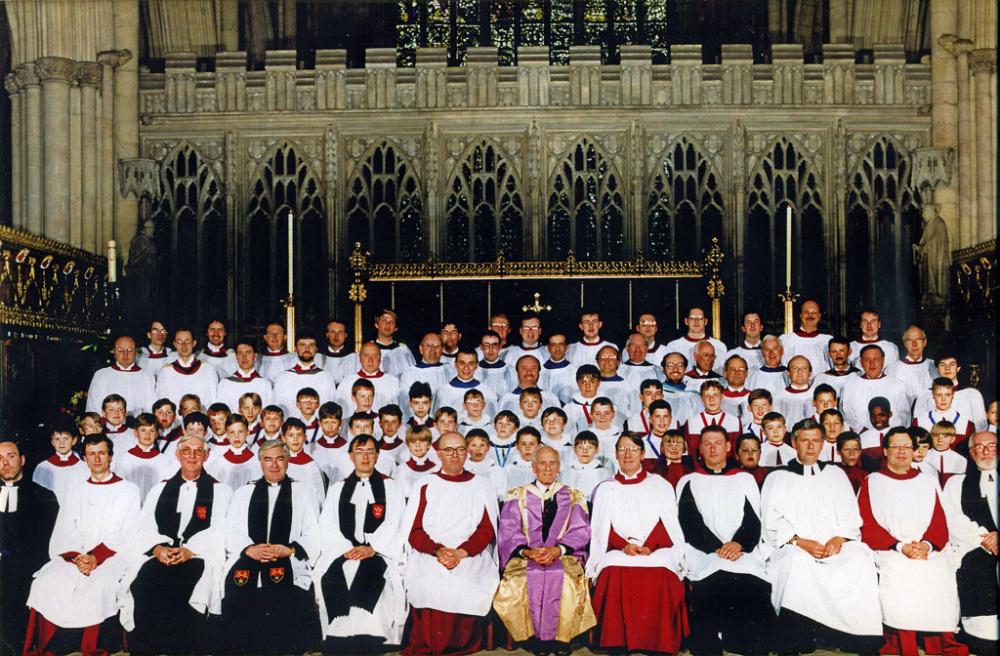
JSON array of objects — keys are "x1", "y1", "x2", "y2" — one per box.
[{"x1": 677, "y1": 426, "x2": 774, "y2": 654}]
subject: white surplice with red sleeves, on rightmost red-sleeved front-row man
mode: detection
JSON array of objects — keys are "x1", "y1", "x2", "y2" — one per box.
[{"x1": 858, "y1": 470, "x2": 959, "y2": 633}]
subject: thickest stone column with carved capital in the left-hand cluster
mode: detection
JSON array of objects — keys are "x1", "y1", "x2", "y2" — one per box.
[{"x1": 35, "y1": 57, "x2": 76, "y2": 243}]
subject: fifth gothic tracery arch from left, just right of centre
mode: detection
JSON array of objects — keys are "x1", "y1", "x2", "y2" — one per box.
[{"x1": 547, "y1": 137, "x2": 625, "y2": 260}]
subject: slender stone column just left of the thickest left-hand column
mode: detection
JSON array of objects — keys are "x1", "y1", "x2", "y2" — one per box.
[{"x1": 14, "y1": 62, "x2": 44, "y2": 235}]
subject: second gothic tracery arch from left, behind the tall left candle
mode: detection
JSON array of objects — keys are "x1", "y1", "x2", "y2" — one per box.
[{"x1": 243, "y1": 141, "x2": 328, "y2": 324}]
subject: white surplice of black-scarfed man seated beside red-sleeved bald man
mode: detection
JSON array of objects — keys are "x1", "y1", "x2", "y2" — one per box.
[{"x1": 313, "y1": 472, "x2": 406, "y2": 645}]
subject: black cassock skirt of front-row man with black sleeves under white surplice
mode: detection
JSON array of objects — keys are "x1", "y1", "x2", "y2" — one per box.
[{"x1": 686, "y1": 572, "x2": 775, "y2": 656}]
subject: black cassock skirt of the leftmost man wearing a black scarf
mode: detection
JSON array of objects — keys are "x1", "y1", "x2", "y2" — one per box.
[{"x1": 128, "y1": 558, "x2": 207, "y2": 655}]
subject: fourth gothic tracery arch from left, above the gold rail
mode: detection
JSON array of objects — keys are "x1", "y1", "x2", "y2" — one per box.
[{"x1": 445, "y1": 139, "x2": 524, "y2": 262}]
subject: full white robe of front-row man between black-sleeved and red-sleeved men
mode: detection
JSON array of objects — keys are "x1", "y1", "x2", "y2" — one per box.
[{"x1": 761, "y1": 460, "x2": 882, "y2": 636}]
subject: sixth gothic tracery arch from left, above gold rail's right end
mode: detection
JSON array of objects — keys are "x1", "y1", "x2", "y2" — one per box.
[{"x1": 647, "y1": 137, "x2": 723, "y2": 260}]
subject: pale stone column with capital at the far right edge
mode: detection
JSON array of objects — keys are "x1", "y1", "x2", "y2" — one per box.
[{"x1": 969, "y1": 48, "x2": 997, "y2": 243}]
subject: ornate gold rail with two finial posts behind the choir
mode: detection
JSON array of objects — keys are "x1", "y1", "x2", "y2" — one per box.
[{"x1": 347, "y1": 238, "x2": 725, "y2": 350}]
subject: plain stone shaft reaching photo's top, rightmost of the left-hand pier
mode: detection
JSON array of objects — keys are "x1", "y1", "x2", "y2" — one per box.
[{"x1": 114, "y1": 0, "x2": 139, "y2": 251}]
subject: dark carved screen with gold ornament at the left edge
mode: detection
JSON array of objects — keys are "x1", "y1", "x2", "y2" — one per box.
[{"x1": 0, "y1": 226, "x2": 109, "y2": 335}]
